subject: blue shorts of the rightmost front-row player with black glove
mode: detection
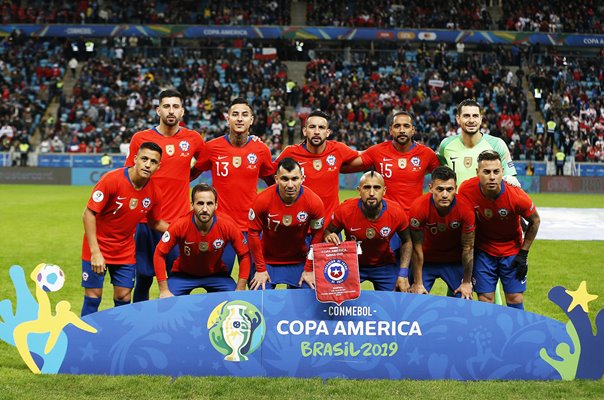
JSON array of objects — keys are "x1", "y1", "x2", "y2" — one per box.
[{"x1": 474, "y1": 250, "x2": 526, "y2": 293}]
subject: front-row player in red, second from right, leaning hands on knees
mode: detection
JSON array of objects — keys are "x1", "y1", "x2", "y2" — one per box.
[{"x1": 409, "y1": 166, "x2": 476, "y2": 299}]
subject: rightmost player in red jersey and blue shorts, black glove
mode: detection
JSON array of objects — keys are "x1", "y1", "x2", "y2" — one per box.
[{"x1": 459, "y1": 150, "x2": 541, "y2": 310}]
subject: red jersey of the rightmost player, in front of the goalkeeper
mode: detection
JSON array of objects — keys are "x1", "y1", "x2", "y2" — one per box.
[{"x1": 459, "y1": 177, "x2": 536, "y2": 257}]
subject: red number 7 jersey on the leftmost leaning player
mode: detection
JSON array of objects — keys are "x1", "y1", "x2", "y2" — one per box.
[{"x1": 82, "y1": 168, "x2": 161, "y2": 264}]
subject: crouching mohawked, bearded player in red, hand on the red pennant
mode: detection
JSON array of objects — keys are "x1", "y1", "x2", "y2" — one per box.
[{"x1": 325, "y1": 171, "x2": 411, "y2": 292}]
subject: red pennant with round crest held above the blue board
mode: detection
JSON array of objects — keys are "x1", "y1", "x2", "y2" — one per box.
[{"x1": 311, "y1": 241, "x2": 361, "y2": 305}]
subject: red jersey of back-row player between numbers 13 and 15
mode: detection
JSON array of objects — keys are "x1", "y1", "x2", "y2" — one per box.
[{"x1": 274, "y1": 140, "x2": 359, "y2": 225}]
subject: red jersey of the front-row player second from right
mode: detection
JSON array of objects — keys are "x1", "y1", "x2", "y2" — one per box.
[{"x1": 409, "y1": 193, "x2": 476, "y2": 264}]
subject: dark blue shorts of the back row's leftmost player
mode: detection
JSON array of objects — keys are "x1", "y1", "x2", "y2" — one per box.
[{"x1": 134, "y1": 223, "x2": 178, "y2": 276}]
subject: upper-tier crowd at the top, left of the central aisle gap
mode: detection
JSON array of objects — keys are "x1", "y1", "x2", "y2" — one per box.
[{"x1": 0, "y1": 0, "x2": 291, "y2": 25}]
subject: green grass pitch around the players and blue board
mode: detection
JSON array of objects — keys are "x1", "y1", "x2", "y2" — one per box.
[{"x1": 0, "y1": 185, "x2": 604, "y2": 400}]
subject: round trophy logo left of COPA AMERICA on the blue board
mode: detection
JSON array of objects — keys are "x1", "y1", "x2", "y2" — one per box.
[{"x1": 208, "y1": 301, "x2": 266, "y2": 362}]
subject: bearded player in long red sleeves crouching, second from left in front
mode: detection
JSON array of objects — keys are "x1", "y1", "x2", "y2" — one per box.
[{"x1": 153, "y1": 183, "x2": 250, "y2": 298}]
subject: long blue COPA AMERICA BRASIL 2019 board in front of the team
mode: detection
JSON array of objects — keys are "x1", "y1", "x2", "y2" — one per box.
[{"x1": 0, "y1": 266, "x2": 604, "y2": 380}]
